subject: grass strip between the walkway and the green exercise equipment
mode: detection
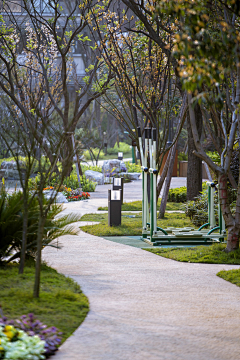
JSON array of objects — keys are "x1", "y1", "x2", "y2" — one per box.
[{"x1": 145, "y1": 244, "x2": 240, "y2": 265}]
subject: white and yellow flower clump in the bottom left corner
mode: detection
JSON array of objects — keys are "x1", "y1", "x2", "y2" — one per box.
[{"x1": 0, "y1": 325, "x2": 45, "y2": 360}]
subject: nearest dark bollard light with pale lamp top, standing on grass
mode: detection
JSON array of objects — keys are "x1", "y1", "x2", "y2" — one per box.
[{"x1": 108, "y1": 190, "x2": 122, "y2": 226}]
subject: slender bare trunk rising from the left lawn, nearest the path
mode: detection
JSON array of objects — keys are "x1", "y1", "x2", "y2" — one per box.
[{"x1": 33, "y1": 216, "x2": 45, "y2": 298}]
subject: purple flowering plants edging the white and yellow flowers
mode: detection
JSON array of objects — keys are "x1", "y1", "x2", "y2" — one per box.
[{"x1": 0, "y1": 313, "x2": 62, "y2": 359}]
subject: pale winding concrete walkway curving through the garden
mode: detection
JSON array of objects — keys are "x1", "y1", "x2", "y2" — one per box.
[{"x1": 43, "y1": 180, "x2": 240, "y2": 360}]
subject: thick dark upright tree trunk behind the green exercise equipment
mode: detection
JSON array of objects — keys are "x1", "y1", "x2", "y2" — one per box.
[{"x1": 187, "y1": 105, "x2": 202, "y2": 200}]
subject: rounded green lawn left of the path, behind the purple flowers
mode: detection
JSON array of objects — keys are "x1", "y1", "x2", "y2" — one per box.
[{"x1": 0, "y1": 264, "x2": 89, "y2": 340}]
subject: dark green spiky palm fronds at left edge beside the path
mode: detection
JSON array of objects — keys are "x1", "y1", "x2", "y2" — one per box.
[{"x1": 0, "y1": 188, "x2": 79, "y2": 262}]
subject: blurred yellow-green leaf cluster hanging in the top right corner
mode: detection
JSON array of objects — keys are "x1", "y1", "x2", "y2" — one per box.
[{"x1": 158, "y1": 0, "x2": 239, "y2": 95}]
